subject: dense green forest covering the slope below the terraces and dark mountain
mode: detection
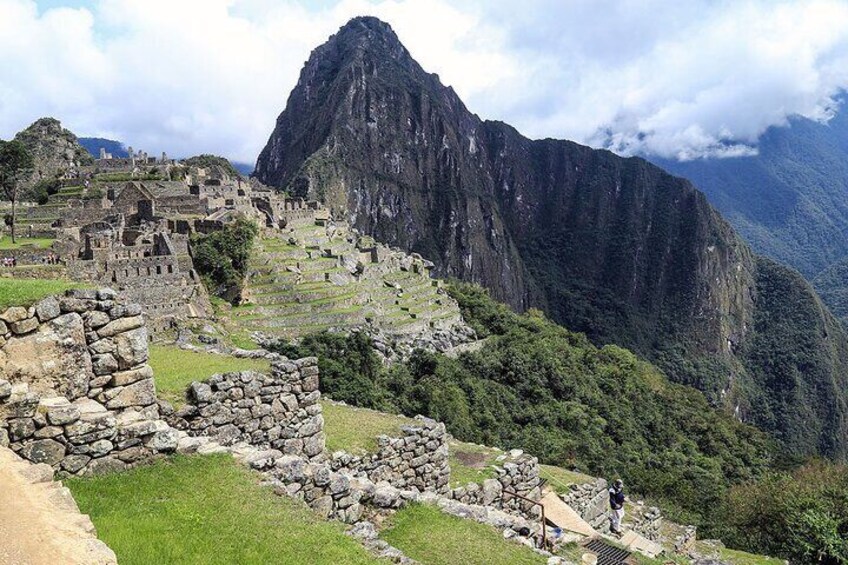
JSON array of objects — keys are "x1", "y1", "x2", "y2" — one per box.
[{"x1": 279, "y1": 283, "x2": 770, "y2": 523}]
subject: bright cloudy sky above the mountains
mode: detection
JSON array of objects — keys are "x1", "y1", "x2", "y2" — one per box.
[{"x1": 0, "y1": 0, "x2": 848, "y2": 162}]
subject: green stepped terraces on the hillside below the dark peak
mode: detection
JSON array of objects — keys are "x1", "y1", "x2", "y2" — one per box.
[{"x1": 235, "y1": 220, "x2": 468, "y2": 339}]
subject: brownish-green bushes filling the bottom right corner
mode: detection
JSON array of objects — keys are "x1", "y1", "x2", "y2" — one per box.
[{"x1": 717, "y1": 462, "x2": 848, "y2": 565}]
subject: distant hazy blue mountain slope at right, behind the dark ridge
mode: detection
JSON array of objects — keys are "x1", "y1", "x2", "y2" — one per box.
[{"x1": 648, "y1": 101, "x2": 848, "y2": 320}]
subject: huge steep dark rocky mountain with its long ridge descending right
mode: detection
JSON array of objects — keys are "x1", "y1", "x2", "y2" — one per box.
[{"x1": 254, "y1": 18, "x2": 848, "y2": 456}]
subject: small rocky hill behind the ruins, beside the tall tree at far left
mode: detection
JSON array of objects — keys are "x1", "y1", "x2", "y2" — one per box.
[{"x1": 15, "y1": 118, "x2": 94, "y2": 192}]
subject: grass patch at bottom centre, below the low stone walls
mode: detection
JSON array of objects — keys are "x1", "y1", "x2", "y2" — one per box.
[{"x1": 380, "y1": 505, "x2": 546, "y2": 565}]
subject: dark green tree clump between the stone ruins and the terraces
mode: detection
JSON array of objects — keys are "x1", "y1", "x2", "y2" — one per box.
[{"x1": 191, "y1": 218, "x2": 259, "y2": 302}]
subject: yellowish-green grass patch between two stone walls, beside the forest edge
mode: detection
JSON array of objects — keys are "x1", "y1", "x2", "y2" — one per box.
[{"x1": 321, "y1": 401, "x2": 415, "y2": 454}]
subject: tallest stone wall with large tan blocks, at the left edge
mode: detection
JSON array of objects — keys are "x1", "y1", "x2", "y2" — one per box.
[{"x1": 0, "y1": 289, "x2": 178, "y2": 474}]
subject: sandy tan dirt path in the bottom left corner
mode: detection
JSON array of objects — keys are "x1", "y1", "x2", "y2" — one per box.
[{"x1": 0, "y1": 447, "x2": 117, "y2": 565}]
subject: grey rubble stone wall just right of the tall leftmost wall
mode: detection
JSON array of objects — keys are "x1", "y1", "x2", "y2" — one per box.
[{"x1": 171, "y1": 357, "x2": 325, "y2": 459}]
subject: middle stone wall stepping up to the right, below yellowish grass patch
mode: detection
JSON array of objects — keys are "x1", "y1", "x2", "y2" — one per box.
[{"x1": 331, "y1": 416, "x2": 450, "y2": 493}]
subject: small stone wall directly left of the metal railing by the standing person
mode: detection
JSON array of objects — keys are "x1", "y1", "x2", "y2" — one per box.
[{"x1": 449, "y1": 450, "x2": 541, "y2": 519}]
